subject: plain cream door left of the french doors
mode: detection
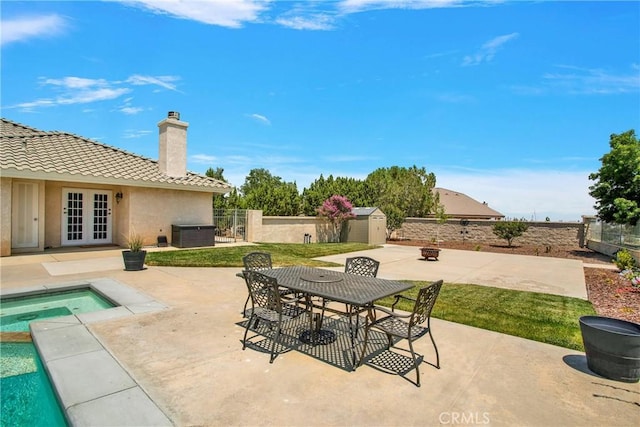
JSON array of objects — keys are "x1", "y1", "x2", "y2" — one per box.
[{"x1": 11, "y1": 182, "x2": 38, "y2": 248}]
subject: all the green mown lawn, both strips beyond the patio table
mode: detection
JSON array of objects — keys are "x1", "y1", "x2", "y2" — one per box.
[{"x1": 146, "y1": 243, "x2": 596, "y2": 351}]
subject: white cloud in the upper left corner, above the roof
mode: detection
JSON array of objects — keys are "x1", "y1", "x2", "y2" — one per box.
[{"x1": 0, "y1": 15, "x2": 67, "y2": 46}]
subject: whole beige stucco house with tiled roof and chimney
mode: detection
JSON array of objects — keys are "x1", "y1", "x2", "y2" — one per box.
[{"x1": 0, "y1": 112, "x2": 232, "y2": 256}]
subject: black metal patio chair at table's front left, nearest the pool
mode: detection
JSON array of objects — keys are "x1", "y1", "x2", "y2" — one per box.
[{"x1": 242, "y1": 270, "x2": 313, "y2": 363}]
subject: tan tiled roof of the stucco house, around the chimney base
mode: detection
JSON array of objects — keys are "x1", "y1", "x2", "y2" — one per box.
[{"x1": 0, "y1": 118, "x2": 232, "y2": 193}]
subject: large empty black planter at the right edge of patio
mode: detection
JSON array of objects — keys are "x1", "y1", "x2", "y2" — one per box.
[{"x1": 580, "y1": 316, "x2": 640, "y2": 382}]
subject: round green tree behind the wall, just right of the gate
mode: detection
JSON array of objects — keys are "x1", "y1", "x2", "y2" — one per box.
[{"x1": 239, "y1": 169, "x2": 301, "y2": 216}]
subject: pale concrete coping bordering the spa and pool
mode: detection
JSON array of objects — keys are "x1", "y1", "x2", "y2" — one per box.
[{"x1": 0, "y1": 278, "x2": 173, "y2": 426}]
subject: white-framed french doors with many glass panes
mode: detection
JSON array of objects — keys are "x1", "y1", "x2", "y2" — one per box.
[{"x1": 62, "y1": 188, "x2": 112, "y2": 246}]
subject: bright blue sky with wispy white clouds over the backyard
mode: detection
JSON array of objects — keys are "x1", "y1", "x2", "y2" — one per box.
[{"x1": 1, "y1": 0, "x2": 640, "y2": 221}]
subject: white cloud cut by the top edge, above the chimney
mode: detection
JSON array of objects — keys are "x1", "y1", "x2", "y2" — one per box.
[{"x1": 123, "y1": 0, "x2": 270, "y2": 28}]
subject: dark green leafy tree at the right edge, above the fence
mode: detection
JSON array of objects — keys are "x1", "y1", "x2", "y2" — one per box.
[{"x1": 589, "y1": 130, "x2": 640, "y2": 226}]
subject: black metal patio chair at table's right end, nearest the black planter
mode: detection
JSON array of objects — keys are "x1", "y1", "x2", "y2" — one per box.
[{"x1": 358, "y1": 280, "x2": 442, "y2": 387}]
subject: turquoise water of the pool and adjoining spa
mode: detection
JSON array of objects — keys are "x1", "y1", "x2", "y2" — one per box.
[{"x1": 0, "y1": 289, "x2": 114, "y2": 427}]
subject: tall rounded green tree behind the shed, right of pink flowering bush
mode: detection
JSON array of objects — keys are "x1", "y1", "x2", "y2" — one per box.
[{"x1": 366, "y1": 165, "x2": 436, "y2": 237}]
